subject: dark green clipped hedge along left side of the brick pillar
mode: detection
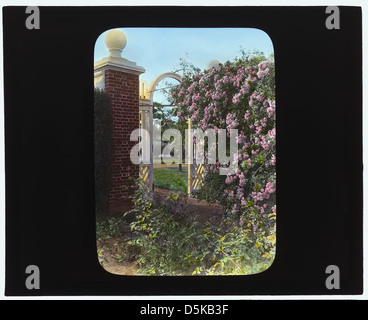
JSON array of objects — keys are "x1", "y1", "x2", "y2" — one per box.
[{"x1": 94, "y1": 88, "x2": 112, "y2": 215}]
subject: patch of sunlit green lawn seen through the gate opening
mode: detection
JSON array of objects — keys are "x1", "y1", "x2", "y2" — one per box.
[{"x1": 153, "y1": 166, "x2": 188, "y2": 193}]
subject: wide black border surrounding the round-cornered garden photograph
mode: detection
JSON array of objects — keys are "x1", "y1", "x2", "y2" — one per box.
[{"x1": 3, "y1": 6, "x2": 363, "y2": 296}]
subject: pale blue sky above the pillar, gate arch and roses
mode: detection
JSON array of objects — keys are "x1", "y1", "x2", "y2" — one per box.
[{"x1": 95, "y1": 28, "x2": 273, "y2": 103}]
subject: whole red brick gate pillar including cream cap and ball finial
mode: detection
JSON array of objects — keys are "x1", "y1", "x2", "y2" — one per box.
[{"x1": 95, "y1": 30, "x2": 144, "y2": 214}]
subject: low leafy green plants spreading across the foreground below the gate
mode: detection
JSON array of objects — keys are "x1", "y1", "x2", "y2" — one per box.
[{"x1": 128, "y1": 180, "x2": 275, "y2": 275}]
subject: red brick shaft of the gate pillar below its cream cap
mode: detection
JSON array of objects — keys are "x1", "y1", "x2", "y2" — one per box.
[{"x1": 105, "y1": 70, "x2": 139, "y2": 214}]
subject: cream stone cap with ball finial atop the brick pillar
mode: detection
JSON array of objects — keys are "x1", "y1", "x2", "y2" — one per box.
[{"x1": 94, "y1": 29, "x2": 146, "y2": 75}]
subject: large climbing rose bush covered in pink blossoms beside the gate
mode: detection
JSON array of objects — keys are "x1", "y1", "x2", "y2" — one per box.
[{"x1": 171, "y1": 54, "x2": 276, "y2": 247}]
